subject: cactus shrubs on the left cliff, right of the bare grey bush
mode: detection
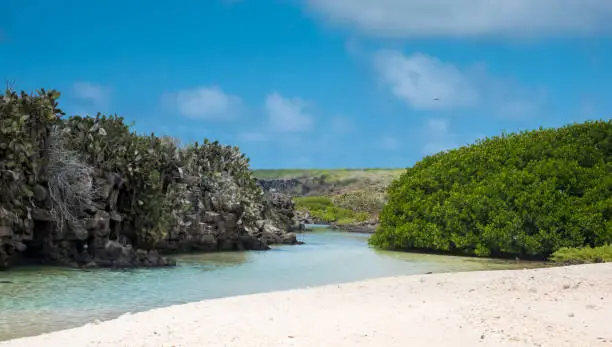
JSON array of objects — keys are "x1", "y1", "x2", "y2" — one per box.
[{"x1": 58, "y1": 114, "x2": 262, "y2": 248}]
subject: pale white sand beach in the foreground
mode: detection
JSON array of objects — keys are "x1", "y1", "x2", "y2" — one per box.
[{"x1": 0, "y1": 264, "x2": 612, "y2": 347}]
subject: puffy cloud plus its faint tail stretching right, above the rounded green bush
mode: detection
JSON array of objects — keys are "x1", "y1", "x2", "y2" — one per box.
[{"x1": 374, "y1": 50, "x2": 546, "y2": 118}]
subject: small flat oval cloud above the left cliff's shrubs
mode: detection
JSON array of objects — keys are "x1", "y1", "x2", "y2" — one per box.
[{"x1": 172, "y1": 86, "x2": 243, "y2": 120}]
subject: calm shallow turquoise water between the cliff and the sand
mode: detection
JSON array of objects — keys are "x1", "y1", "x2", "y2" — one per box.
[{"x1": 0, "y1": 229, "x2": 534, "y2": 340}]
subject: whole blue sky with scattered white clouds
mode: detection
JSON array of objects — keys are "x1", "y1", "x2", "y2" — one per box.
[{"x1": 0, "y1": 0, "x2": 612, "y2": 168}]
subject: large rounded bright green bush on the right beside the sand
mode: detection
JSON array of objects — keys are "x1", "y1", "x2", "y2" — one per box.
[{"x1": 370, "y1": 121, "x2": 612, "y2": 257}]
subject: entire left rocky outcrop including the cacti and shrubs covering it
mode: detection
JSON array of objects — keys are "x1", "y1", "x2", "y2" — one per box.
[{"x1": 0, "y1": 89, "x2": 302, "y2": 268}]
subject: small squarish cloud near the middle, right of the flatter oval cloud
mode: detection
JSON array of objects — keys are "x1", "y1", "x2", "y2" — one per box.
[{"x1": 265, "y1": 92, "x2": 314, "y2": 132}]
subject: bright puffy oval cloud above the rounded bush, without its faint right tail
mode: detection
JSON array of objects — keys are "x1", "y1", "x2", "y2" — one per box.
[{"x1": 374, "y1": 50, "x2": 478, "y2": 109}]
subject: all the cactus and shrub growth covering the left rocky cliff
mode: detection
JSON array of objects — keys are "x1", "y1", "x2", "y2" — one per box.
[{"x1": 0, "y1": 90, "x2": 263, "y2": 253}]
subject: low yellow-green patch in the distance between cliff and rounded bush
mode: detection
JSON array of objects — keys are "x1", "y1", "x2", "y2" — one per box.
[{"x1": 295, "y1": 196, "x2": 369, "y2": 224}]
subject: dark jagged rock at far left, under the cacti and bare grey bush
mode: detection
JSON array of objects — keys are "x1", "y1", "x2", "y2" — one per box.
[{"x1": 0, "y1": 173, "x2": 174, "y2": 268}]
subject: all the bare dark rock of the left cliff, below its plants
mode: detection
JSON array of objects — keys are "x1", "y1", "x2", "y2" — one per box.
[{"x1": 0, "y1": 172, "x2": 299, "y2": 268}]
